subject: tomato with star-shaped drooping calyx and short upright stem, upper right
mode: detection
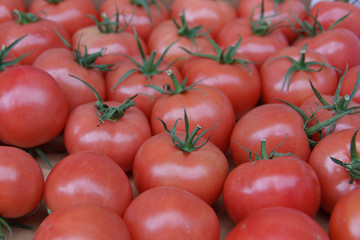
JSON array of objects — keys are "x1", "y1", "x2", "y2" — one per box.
[{"x1": 259, "y1": 46, "x2": 338, "y2": 106}]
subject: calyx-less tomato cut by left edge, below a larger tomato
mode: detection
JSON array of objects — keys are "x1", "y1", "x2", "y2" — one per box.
[{"x1": 0, "y1": 146, "x2": 44, "y2": 218}]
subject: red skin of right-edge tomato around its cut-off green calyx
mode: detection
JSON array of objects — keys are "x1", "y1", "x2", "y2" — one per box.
[{"x1": 309, "y1": 129, "x2": 360, "y2": 213}]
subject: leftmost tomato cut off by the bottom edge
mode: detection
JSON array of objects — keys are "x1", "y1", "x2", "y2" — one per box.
[{"x1": 34, "y1": 204, "x2": 131, "y2": 240}]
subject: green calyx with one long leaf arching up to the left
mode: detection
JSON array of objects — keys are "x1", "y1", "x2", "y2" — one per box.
[{"x1": 70, "y1": 75, "x2": 138, "y2": 126}]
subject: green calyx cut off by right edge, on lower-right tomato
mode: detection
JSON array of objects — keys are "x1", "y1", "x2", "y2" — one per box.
[{"x1": 329, "y1": 130, "x2": 360, "y2": 184}]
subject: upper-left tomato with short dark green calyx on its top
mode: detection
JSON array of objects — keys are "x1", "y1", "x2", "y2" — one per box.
[{"x1": 0, "y1": 11, "x2": 70, "y2": 64}]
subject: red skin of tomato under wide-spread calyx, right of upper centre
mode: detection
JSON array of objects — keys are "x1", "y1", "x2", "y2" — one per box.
[{"x1": 181, "y1": 54, "x2": 261, "y2": 119}]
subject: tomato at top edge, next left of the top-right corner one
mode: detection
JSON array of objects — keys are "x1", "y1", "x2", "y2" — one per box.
[{"x1": 237, "y1": 0, "x2": 306, "y2": 43}]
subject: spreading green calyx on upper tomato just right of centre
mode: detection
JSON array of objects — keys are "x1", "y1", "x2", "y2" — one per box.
[{"x1": 182, "y1": 37, "x2": 256, "y2": 70}]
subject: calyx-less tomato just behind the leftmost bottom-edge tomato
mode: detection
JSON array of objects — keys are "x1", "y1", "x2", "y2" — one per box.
[{"x1": 44, "y1": 151, "x2": 133, "y2": 216}]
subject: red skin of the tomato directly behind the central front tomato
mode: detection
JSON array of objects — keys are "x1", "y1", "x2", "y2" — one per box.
[{"x1": 150, "y1": 84, "x2": 235, "y2": 152}]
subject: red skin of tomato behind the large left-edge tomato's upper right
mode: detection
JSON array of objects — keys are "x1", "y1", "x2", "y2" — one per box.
[{"x1": 33, "y1": 48, "x2": 106, "y2": 111}]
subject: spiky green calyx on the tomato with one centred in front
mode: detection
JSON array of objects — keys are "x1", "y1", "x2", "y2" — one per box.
[{"x1": 158, "y1": 107, "x2": 216, "y2": 153}]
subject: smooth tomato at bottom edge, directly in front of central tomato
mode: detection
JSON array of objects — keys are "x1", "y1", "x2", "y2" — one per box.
[{"x1": 124, "y1": 187, "x2": 220, "y2": 240}]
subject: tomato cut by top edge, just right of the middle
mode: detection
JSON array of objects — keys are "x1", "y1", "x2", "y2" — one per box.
[{"x1": 171, "y1": 0, "x2": 236, "y2": 36}]
